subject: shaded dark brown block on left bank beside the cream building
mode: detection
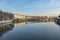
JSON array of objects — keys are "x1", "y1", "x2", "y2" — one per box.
[{"x1": 0, "y1": 11, "x2": 14, "y2": 21}]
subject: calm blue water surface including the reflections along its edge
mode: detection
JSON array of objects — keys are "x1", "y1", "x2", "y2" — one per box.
[{"x1": 0, "y1": 22, "x2": 60, "y2": 40}]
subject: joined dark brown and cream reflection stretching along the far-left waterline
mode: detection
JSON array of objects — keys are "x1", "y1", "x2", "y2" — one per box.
[{"x1": 0, "y1": 22, "x2": 32, "y2": 37}]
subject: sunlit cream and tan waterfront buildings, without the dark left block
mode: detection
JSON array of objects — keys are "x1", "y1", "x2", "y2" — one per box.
[{"x1": 14, "y1": 14, "x2": 54, "y2": 22}]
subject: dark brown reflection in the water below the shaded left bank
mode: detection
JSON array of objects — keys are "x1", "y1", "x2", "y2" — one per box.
[{"x1": 0, "y1": 24, "x2": 14, "y2": 37}]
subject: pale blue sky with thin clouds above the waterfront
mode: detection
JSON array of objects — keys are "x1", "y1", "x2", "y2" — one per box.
[{"x1": 0, "y1": 0, "x2": 60, "y2": 16}]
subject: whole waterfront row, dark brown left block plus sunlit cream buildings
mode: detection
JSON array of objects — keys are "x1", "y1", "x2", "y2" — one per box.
[{"x1": 0, "y1": 11, "x2": 54, "y2": 22}]
